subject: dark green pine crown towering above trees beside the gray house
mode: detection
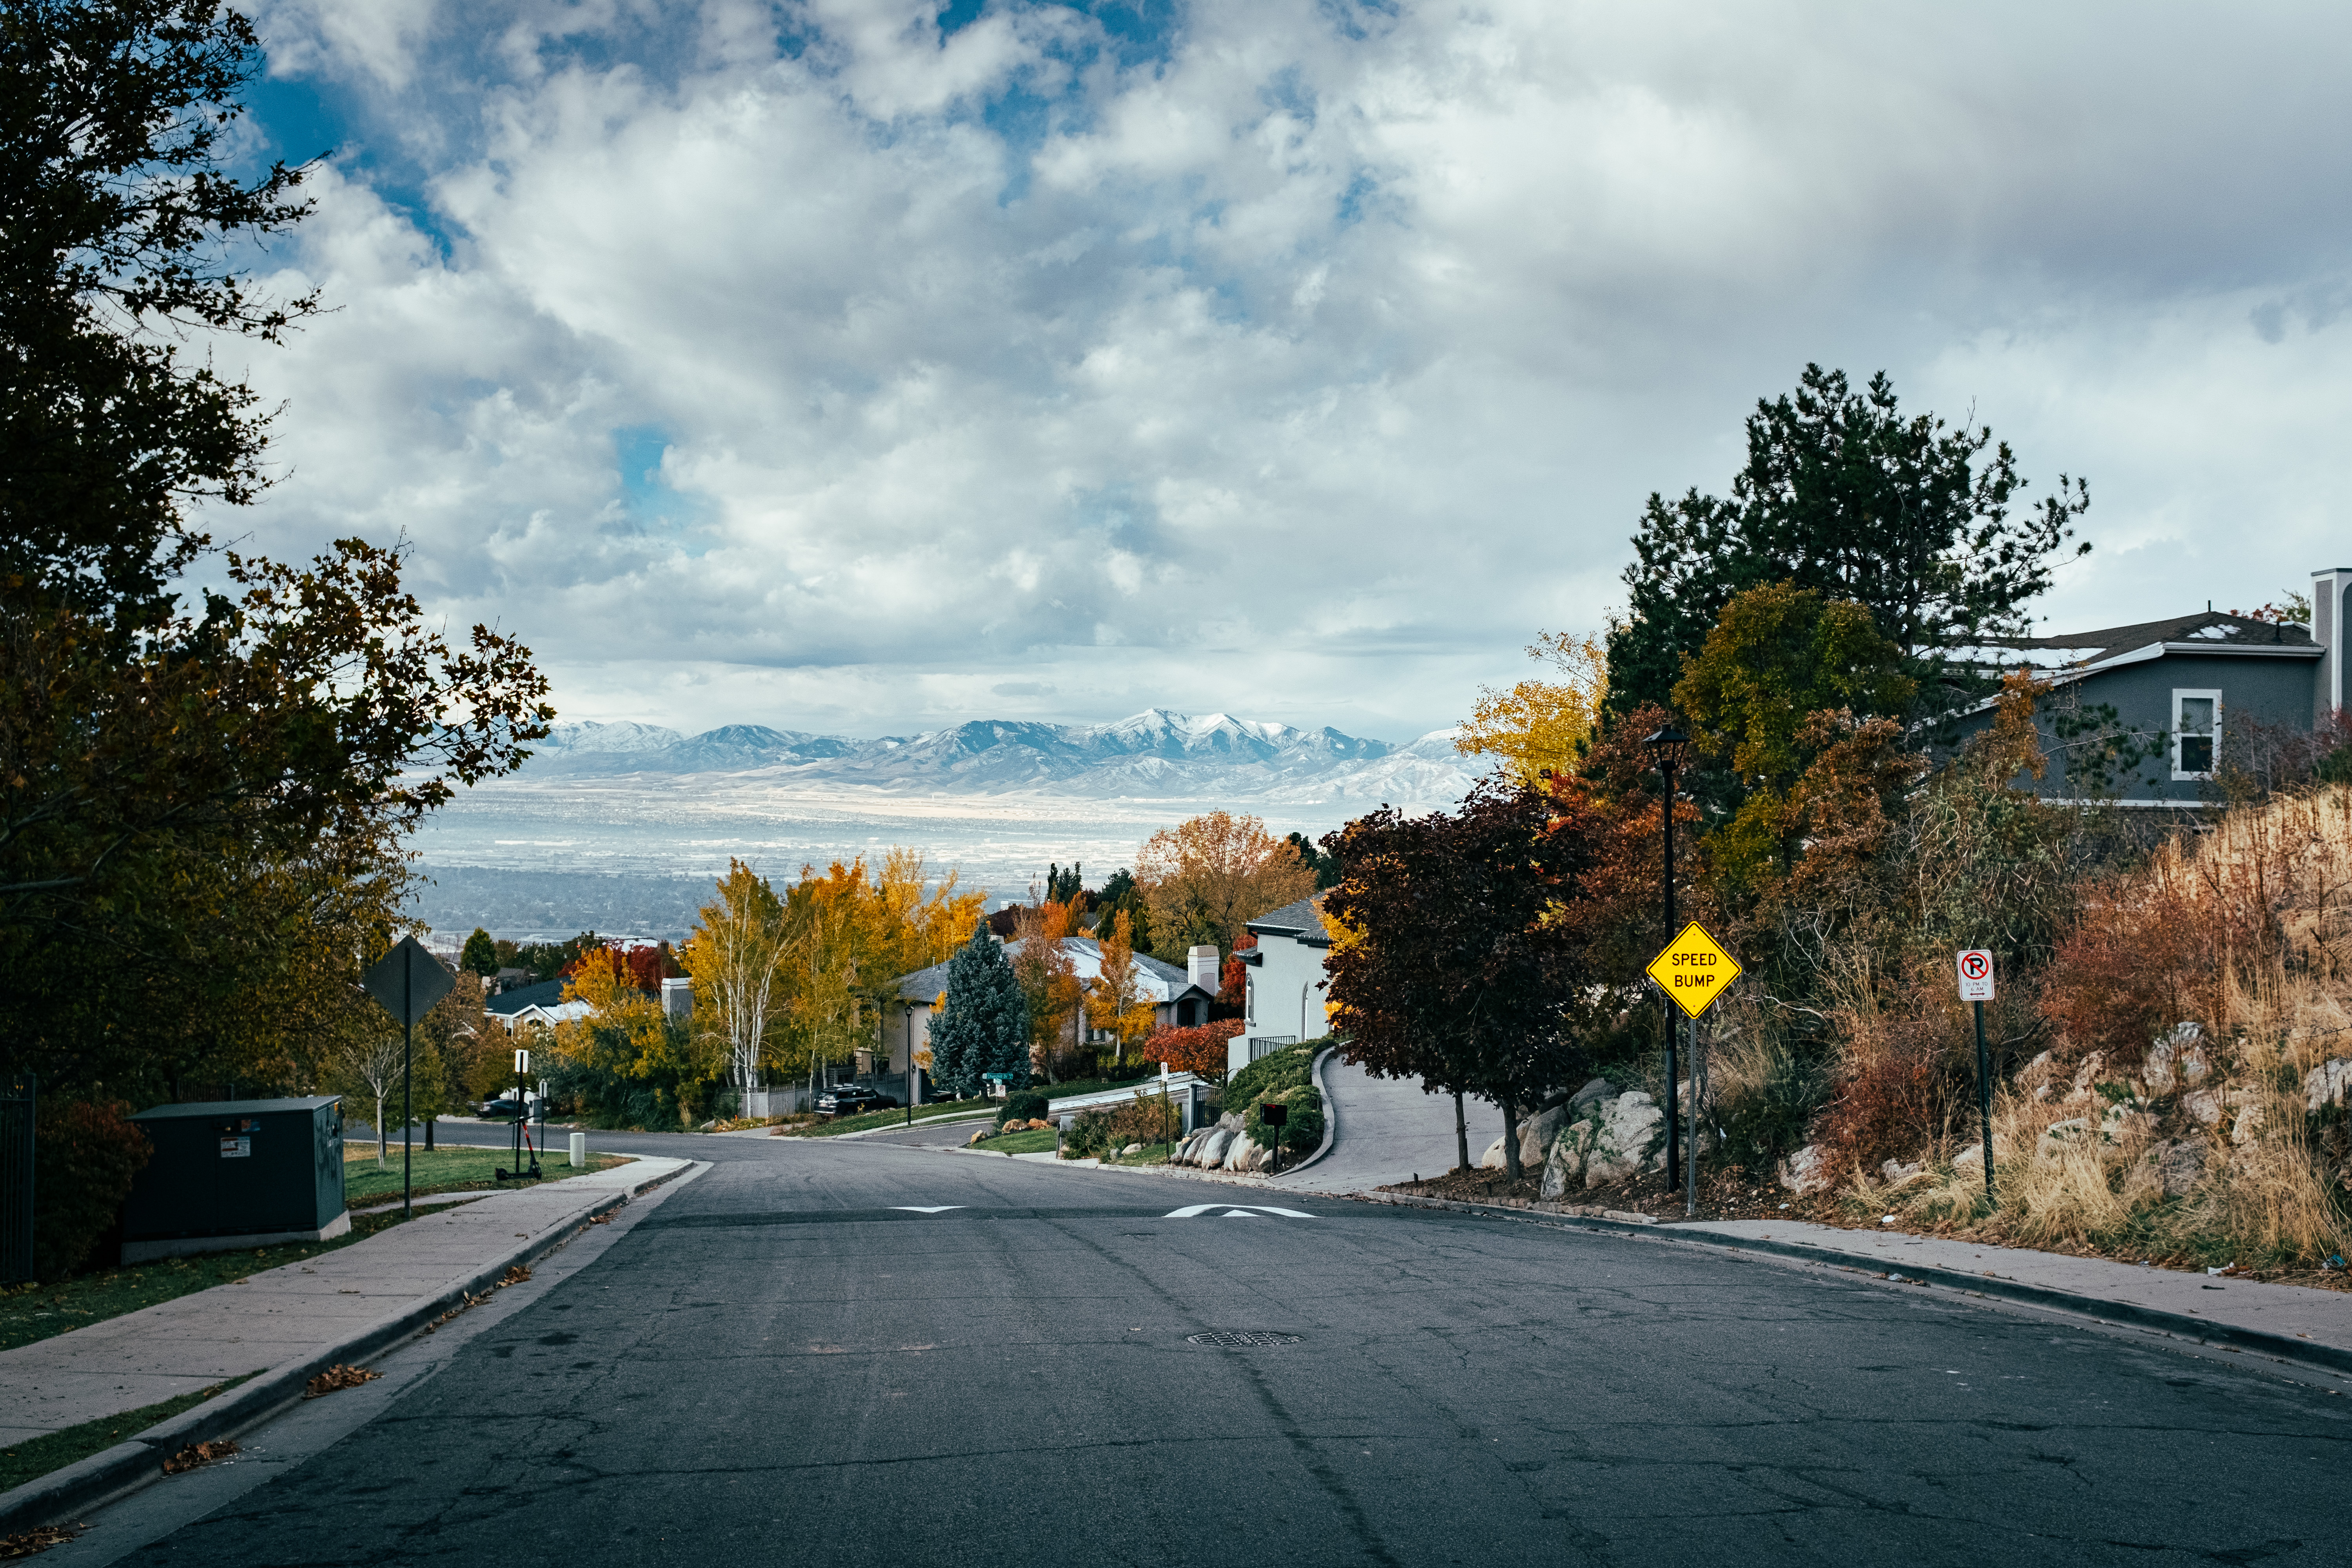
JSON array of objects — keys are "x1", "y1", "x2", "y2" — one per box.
[{"x1": 1606, "y1": 365, "x2": 2091, "y2": 712}]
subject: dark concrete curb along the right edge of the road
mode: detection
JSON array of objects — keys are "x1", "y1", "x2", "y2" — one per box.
[{"x1": 1345, "y1": 1192, "x2": 2352, "y2": 1373}]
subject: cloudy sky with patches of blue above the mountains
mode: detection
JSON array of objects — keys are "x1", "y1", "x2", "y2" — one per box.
[{"x1": 214, "y1": 0, "x2": 2352, "y2": 738}]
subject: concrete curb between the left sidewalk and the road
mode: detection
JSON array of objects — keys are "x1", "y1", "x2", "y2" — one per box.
[{"x1": 0, "y1": 1159, "x2": 710, "y2": 1535}]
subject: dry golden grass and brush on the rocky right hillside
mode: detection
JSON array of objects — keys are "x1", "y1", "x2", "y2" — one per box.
[{"x1": 1842, "y1": 788, "x2": 2352, "y2": 1267}]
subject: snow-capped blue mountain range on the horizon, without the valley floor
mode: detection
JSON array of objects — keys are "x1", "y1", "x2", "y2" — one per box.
[{"x1": 522, "y1": 708, "x2": 1477, "y2": 806}]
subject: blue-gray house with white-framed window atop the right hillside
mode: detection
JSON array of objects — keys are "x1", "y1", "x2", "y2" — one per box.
[{"x1": 1957, "y1": 566, "x2": 2352, "y2": 806}]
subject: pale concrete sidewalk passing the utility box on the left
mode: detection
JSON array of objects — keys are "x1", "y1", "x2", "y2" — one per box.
[{"x1": 0, "y1": 1157, "x2": 694, "y2": 1443}]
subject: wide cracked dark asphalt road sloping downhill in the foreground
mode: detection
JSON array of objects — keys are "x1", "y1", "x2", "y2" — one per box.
[{"x1": 59, "y1": 1138, "x2": 2352, "y2": 1568}]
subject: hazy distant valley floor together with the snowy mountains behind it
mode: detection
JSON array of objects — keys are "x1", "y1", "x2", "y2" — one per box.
[{"x1": 414, "y1": 708, "x2": 1479, "y2": 938}]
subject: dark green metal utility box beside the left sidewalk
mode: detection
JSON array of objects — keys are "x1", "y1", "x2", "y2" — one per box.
[{"x1": 122, "y1": 1096, "x2": 350, "y2": 1262}]
